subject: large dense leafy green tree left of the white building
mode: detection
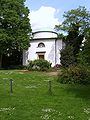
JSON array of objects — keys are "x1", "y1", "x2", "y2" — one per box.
[{"x1": 0, "y1": 0, "x2": 31, "y2": 65}]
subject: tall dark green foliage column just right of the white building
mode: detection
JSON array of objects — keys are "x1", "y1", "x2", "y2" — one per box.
[{"x1": 61, "y1": 25, "x2": 83, "y2": 67}]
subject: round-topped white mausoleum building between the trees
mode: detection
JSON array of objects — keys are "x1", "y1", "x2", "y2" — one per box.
[{"x1": 23, "y1": 31, "x2": 63, "y2": 67}]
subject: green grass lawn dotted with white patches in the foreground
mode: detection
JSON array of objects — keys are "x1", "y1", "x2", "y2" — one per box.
[{"x1": 0, "y1": 70, "x2": 90, "y2": 120}]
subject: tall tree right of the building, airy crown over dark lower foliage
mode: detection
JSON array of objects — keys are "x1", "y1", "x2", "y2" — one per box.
[{"x1": 55, "y1": 6, "x2": 90, "y2": 66}]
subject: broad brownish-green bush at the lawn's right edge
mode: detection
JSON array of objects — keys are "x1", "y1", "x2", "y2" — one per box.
[{"x1": 58, "y1": 65, "x2": 90, "y2": 85}]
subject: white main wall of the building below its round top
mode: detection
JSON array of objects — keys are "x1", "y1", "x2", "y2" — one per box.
[{"x1": 23, "y1": 39, "x2": 62, "y2": 67}]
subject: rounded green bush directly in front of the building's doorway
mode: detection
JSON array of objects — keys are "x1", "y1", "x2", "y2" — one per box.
[{"x1": 27, "y1": 59, "x2": 51, "y2": 71}]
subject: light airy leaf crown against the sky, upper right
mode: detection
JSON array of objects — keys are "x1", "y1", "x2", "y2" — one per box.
[{"x1": 56, "y1": 6, "x2": 90, "y2": 33}]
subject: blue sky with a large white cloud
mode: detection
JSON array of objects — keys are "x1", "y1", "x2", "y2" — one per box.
[{"x1": 25, "y1": 0, "x2": 90, "y2": 31}]
